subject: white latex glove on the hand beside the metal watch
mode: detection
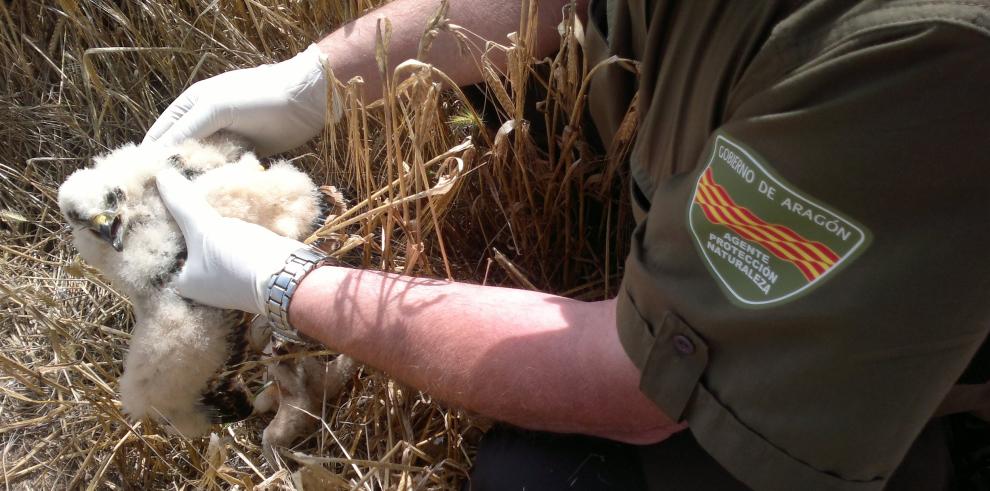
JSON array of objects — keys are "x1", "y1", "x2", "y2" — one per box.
[{"x1": 155, "y1": 169, "x2": 303, "y2": 314}]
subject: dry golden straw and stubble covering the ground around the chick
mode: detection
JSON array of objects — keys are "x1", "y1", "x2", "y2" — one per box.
[{"x1": 0, "y1": 0, "x2": 635, "y2": 489}]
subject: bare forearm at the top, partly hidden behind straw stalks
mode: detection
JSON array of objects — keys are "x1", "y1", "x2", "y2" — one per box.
[{"x1": 318, "y1": 0, "x2": 586, "y2": 100}]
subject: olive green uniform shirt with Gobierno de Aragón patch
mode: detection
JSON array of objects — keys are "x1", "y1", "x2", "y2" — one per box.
[{"x1": 585, "y1": 0, "x2": 990, "y2": 490}]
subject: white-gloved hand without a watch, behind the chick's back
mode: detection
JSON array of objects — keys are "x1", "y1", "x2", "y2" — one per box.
[{"x1": 144, "y1": 44, "x2": 340, "y2": 157}]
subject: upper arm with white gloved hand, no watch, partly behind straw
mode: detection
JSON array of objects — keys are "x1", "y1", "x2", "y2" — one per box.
[{"x1": 144, "y1": 0, "x2": 585, "y2": 152}]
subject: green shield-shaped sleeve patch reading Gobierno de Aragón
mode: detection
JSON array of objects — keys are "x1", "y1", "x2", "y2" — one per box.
[{"x1": 688, "y1": 133, "x2": 870, "y2": 308}]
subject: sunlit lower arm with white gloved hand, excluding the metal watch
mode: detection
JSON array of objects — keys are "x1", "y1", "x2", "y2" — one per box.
[{"x1": 158, "y1": 170, "x2": 681, "y2": 443}]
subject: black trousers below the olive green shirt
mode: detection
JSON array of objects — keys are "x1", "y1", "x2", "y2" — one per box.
[{"x1": 464, "y1": 421, "x2": 952, "y2": 491}]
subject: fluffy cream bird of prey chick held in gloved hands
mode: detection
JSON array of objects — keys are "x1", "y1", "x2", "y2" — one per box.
[{"x1": 58, "y1": 135, "x2": 340, "y2": 437}]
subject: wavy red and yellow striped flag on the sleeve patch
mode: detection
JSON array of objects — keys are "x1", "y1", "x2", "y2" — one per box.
[{"x1": 694, "y1": 168, "x2": 839, "y2": 282}]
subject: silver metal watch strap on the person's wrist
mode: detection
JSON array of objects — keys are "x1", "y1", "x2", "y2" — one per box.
[{"x1": 266, "y1": 247, "x2": 328, "y2": 343}]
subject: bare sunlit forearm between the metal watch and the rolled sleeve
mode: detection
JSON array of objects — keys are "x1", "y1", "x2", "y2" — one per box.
[{"x1": 290, "y1": 267, "x2": 679, "y2": 443}]
